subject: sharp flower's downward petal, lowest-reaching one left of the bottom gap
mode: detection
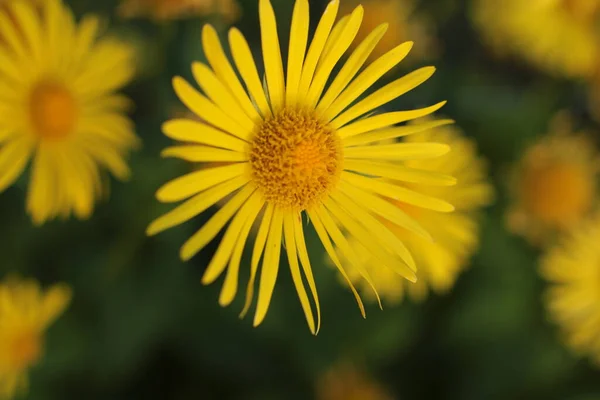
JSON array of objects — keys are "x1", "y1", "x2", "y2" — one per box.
[{"x1": 253, "y1": 208, "x2": 283, "y2": 327}]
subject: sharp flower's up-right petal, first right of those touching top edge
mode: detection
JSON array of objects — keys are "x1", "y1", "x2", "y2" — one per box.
[{"x1": 306, "y1": 6, "x2": 364, "y2": 107}]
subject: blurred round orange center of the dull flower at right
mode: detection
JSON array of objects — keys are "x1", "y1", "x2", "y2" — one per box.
[{"x1": 520, "y1": 163, "x2": 595, "y2": 226}]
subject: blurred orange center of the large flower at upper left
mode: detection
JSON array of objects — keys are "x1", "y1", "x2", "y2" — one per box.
[{"x1": 29, "y1": 81, "x2": 77, "y2": 140}]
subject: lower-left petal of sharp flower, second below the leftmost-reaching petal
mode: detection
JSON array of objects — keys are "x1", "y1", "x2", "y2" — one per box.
[{"x1": 202, "y1": 192, "x2": 264, "y2": 285}]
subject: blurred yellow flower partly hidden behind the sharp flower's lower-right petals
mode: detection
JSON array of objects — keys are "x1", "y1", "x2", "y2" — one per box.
[{"x1": 336, "y1": 120, "x2": 494, "y2": 303}]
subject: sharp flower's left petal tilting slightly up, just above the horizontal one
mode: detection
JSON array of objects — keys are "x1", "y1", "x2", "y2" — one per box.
[{"x1": 162, "y1": 119, "x2": 248, "y2": 153}]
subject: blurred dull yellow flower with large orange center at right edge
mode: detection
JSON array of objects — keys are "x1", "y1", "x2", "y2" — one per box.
[{"x1": 507, "y1": 114, "x2": 598, "y2": 244}]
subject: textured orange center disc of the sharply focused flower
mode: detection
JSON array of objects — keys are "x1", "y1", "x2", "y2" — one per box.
[{"x1": 250, "y1": 109, "x2": 342, "y2": 211}]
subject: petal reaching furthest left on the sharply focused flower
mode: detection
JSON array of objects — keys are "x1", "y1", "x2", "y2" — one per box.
[{"x1": 146, "y1": 175, "x2": 250, "y2": 236}]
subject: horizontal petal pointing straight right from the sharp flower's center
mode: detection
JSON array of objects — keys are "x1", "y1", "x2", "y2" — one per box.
[{"x1": 344, "y1": 143, "x2": 450, "y2": 161}]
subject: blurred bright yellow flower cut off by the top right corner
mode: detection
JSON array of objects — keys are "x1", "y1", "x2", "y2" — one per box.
[{"x1": 472, "y1": 0, "x2": 600, "y2": 78}]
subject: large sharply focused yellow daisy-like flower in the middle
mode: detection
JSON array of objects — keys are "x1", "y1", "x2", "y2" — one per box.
[{"x1": 148, "y1": 0, "x2": 453, "y2": 333}]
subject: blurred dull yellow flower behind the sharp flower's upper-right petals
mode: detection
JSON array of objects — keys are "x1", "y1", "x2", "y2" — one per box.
[{"x1": 340, "y1": 0, "x2": 436, "y2": 61}]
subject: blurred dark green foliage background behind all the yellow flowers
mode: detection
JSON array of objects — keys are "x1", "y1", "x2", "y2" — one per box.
[{"x1": 0, "y1": 0, "x2": 600, "y2": 400}]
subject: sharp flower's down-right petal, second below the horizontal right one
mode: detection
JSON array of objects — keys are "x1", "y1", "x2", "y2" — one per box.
[{"x1": 342, "y1": 171, "x2": 454, "y2": 212}]
